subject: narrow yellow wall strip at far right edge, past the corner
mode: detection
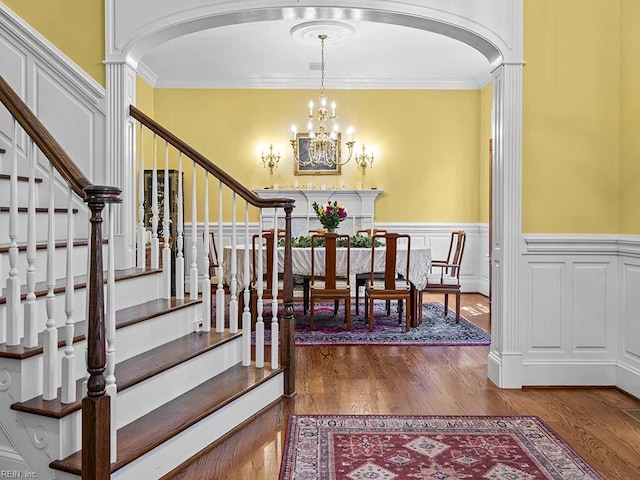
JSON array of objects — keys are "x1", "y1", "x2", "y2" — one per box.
[{"x1": 620, "y1": 0, "x2": 640, "y2": 235}]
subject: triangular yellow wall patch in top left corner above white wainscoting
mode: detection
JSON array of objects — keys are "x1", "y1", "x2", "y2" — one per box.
[{"x1": 3, "y1": 0, "x2": 105, "y2": 86}]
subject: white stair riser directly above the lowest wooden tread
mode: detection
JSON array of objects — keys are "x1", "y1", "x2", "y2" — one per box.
[{"x1": 116, "y1": 334, "x2": 242, "y2": 428}]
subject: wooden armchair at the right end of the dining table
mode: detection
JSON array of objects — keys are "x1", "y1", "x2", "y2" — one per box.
[{"x1": 419, "y1": 230, "x2": 467, "y2": 323}]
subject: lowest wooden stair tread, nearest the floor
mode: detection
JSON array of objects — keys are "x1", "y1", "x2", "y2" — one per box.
[{"x1": 49, "y1": 364, "x2": 283, "y2": 475}]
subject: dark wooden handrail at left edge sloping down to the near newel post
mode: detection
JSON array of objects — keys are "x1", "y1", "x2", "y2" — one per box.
[{"x1": 0, "y1": 75, "x2": 91, "y2": 199}]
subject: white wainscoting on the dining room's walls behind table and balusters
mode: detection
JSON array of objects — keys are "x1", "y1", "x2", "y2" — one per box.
[{"x1": 184, "y1": 223, "x2": 489, "y2": 295}]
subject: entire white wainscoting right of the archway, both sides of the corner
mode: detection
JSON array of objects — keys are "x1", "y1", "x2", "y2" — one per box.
[{"x1": 520, "y1": 235, "x2": 640, "y2": 396}]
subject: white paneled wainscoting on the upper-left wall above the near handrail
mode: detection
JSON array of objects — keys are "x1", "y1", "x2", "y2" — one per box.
[{"x1": 0, "y1": 3, "x2": 106, "y2": 189}]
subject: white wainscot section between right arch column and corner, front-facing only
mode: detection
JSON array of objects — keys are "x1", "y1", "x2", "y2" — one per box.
[{"x1": 521, "y1": 235, "x2": 618, "y2": 385}]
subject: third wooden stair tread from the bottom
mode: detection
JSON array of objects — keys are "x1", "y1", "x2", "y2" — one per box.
[{"x1": 0, "y1": 295, "x2": 202, "y2": 359}]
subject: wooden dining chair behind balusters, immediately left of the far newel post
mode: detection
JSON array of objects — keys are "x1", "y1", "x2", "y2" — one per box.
[{"x1": 249, "y1": 228, "x2": 285, "y2": 326}]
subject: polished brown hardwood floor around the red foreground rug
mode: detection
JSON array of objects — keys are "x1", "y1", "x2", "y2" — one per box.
[{"x1": 165, "y1": 294, "x2": 640, "y2": 480}]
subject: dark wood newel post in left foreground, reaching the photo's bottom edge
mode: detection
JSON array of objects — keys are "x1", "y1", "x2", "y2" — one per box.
[{"x1": 82, "y1": 185, "x2": 121, "y2": 480}]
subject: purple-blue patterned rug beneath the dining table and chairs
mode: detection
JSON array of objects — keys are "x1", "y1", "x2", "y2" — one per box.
[{"x1": 254, "y1": 301, "x2": 491, "y2": 346}]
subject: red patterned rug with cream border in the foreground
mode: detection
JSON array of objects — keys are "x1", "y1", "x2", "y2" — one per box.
[{"x1": 280, "y1": 415, "x2": 602, "y2": 480}]
